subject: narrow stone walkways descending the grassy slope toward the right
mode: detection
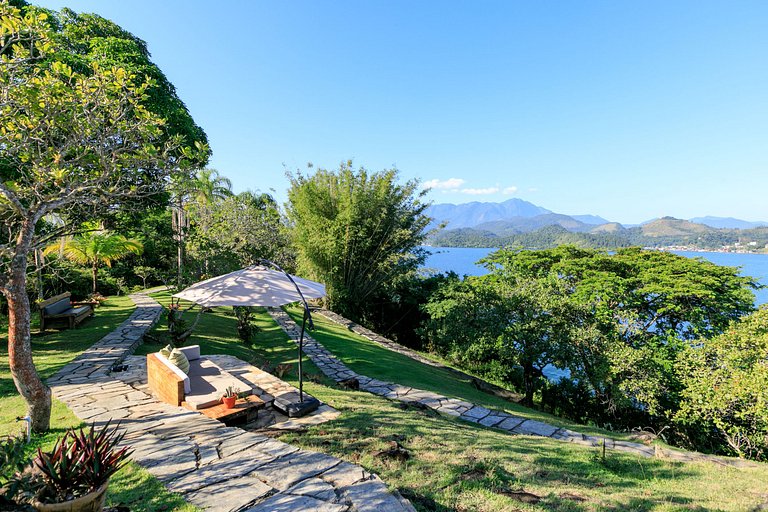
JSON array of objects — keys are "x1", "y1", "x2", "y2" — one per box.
[{"x1": 268, "y1": 308, "x2": 750, "y2": 466}]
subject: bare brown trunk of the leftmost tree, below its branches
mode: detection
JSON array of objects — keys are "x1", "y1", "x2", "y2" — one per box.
[{"x1": 4, "y1": 242, "x2": 51, "y2": 432}]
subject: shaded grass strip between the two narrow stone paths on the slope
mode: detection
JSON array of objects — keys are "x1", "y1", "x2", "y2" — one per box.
[{"x1": 287, "y1": 308, "x2": 628, "y2": 439}]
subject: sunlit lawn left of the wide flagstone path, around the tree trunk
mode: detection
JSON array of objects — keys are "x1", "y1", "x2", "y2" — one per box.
[{"x1": 0, "y1": 297, "x2": 198, "y2": 512}]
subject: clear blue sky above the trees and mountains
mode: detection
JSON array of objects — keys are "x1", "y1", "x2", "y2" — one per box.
[{"x1": 34, "y1": 0, "x2": 768, "y2": 223}]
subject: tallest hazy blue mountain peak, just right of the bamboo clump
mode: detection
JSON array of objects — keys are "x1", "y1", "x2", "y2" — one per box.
[{"x1": 424, "y1": 198, "x2": 552, "y2": 229}]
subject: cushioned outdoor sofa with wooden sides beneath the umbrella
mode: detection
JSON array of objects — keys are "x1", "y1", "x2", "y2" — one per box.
[{"x1": 147, "y1": 345, "x2": 253, "y2": 410}]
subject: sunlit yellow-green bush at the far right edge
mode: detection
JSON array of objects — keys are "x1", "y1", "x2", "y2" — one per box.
[{"x1": 676, "y1": 309, "x2": 768, "y2": 460}]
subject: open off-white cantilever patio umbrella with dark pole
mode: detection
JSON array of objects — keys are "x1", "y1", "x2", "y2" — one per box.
[{"x1": 173, "y1": 260, "x2": 325, "y2": 402}]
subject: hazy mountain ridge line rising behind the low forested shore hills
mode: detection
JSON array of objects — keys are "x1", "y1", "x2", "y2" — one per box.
[{"x1": 425, "y1": 198, "x2": 768, "y2": 236}]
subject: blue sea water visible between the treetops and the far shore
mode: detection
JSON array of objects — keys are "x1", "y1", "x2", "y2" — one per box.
[{"x1": 424, "y1": 247, "x2": 768, "y2": 305}]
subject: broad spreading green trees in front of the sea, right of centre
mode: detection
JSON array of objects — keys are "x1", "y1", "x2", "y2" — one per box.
[{"x1": 423, "y1": 246, "x2": 754, "y2": 450}]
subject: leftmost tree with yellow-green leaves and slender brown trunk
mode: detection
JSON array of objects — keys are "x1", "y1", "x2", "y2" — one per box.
[{"x1": 0, "y1": 2, "x2": 208, "y2": 431}]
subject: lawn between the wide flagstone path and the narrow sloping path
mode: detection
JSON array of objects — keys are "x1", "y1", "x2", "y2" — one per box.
[{"x1": 144, "y1": 295, "x2": 768, "y2": 512}]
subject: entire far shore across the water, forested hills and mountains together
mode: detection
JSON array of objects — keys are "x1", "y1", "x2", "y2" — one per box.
[{"x1": 426, "y1": 199, "x2": 768, "y2": 253}]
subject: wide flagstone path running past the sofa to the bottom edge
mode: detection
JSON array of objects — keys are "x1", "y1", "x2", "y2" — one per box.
[{"x1": 48, "y1": 294, "x2": 415, "y2": 512}]
